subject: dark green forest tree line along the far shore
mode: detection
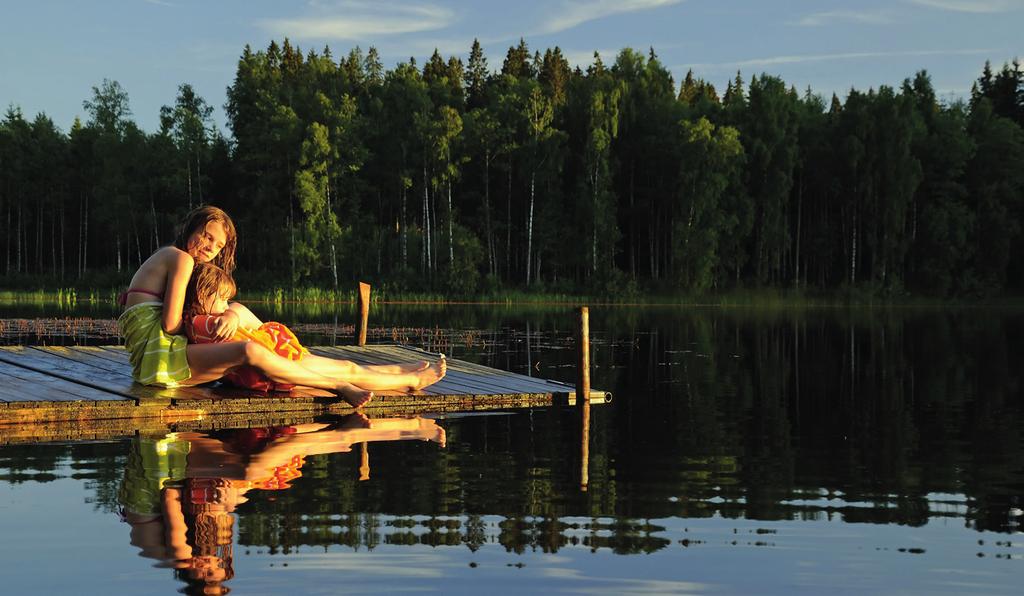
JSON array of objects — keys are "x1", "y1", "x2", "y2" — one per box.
[{"x1": 0, "y1": 39, "x2": 1024, "y2": 296}]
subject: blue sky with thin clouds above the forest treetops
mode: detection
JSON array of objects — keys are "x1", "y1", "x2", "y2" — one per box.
[{"x1": 0, "y1": 0, "x2": 1024, "y2": 132}]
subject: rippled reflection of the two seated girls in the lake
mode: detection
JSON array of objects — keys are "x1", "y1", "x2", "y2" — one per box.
[{"x1": 119, "y1": 414, "x2": 445, "y2": 594}]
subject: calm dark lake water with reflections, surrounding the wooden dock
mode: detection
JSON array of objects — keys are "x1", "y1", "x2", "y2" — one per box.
[{"x1": 0, "y1": 305, "x2": 1024, "y2": 594}]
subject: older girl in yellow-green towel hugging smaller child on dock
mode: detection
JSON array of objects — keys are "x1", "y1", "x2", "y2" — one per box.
[{"x1": 118, "y1": 206, "x2": 445, "y2": 407}]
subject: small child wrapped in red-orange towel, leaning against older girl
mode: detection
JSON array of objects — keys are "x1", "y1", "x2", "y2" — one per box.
[{"x1": 184, "y1": 262, "x2": 309, "y2": 392}]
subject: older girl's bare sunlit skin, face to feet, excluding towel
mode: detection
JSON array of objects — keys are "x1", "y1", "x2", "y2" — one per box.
[{"x1": 127, "y1": 213, "x2": 447, "y2": 408}]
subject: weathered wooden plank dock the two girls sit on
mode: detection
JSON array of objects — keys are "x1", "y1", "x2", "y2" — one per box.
[{"x1": 0, "y1": 345, "x2": 609, "y2": 443}]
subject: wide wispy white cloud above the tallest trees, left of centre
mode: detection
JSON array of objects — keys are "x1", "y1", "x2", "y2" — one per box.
[{"x1": 259, "y1": 1, "x2": 456, "y2": 40}]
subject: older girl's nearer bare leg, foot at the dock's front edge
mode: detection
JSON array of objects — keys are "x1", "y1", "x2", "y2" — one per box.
[{"x1": 186, "y1": 341, "x2": 373, "y2": 408}]
